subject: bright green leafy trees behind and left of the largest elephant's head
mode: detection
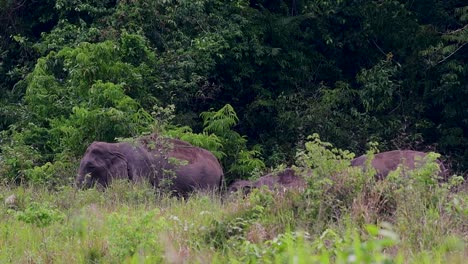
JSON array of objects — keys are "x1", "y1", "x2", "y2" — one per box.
[{"x1": 2, "y1": 34, "x2": 154, "y2": 184}]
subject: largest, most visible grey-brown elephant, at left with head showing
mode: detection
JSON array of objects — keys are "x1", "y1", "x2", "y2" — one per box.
[{"x1": 76, "y1": 136, "x2": 223, "y2": 195}]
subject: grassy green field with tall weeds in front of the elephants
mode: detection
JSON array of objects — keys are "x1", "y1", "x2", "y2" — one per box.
[{"x1": 0, "y1": 167, "x2": 468, "y2": 263}]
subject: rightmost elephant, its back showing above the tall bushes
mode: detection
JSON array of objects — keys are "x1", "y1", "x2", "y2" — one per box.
[{"x1": 351, "y1": 150, "x2": 447, "y2": 180}]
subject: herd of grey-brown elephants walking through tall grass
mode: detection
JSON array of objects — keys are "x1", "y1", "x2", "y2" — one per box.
[{"x1": 76, "y1": 135, "x2": 447, "y2": 196}]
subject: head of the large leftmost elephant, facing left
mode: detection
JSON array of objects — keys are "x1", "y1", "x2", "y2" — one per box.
[{"x1": 76, "y1": 142, "x2": 129, "y2": 188}]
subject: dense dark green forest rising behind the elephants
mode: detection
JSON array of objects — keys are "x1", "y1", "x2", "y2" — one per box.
[{"x1": 0, "y1": 0, "x2": 468, "y2": 182}]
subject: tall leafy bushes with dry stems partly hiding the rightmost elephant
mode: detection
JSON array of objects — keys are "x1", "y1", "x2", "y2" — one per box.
[{"x1": 296, "y1": 135, "x2": 463, "y2": 236}]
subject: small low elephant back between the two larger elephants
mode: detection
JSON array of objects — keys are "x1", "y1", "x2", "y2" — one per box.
[{"x1": 228, "y1": 168, "x2": 307, "y2": 194}]
